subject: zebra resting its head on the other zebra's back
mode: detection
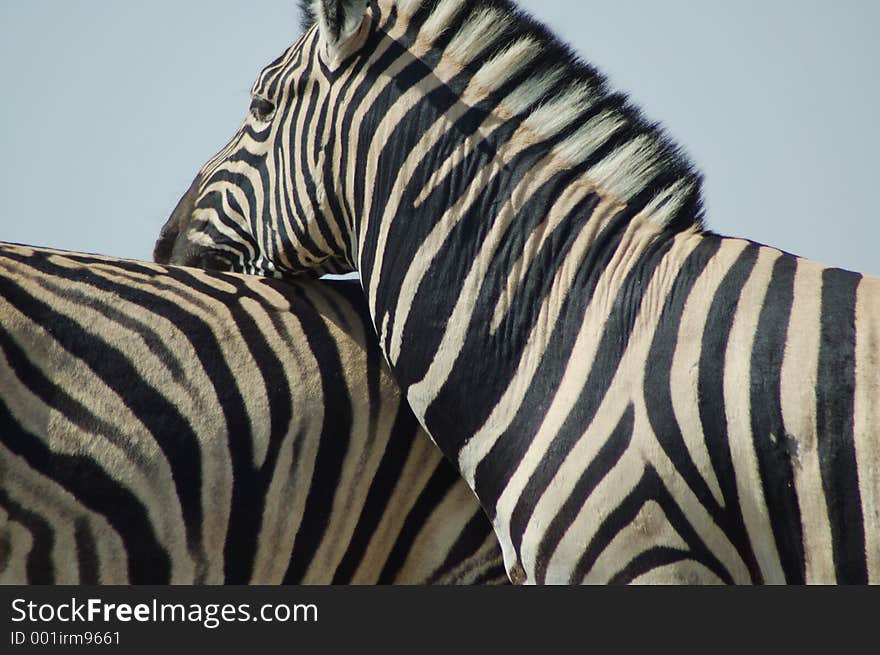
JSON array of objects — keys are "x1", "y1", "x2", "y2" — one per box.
[{"x1": 154, "y1": 0, "x2": 880, "y2": 583}]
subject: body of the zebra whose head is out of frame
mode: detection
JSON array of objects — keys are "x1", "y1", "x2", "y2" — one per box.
[{"x1": 0, "y1": 244, "x2": 507, "y2": 584}]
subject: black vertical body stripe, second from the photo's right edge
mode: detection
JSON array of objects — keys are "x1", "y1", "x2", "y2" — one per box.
[{"x1": 749, "y1": 255, "x2": 806, "y2": 584}]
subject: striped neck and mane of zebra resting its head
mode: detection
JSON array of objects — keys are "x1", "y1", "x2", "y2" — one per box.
[{"x1": 336, "y1": 2, "x2": 700, "y2": 456}]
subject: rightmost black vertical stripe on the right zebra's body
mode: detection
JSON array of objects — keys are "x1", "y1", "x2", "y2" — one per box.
[{"x1": 816, "y1": 268, "x2": 868, "y2": 584}]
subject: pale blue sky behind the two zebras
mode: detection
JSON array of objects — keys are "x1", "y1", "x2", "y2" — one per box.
[{"x1": 0, "y1": 0, "x2": 880, "y2": 274}]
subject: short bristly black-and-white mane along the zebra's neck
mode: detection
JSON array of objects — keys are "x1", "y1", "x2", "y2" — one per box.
[{"x1": 300, "y1": 0, "x2": 702, "y2": 230}]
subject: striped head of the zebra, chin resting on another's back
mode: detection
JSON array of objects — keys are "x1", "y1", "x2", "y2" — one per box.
[{"x1": 153, "y1": 0, "x2": 370, "y2": 277}]
